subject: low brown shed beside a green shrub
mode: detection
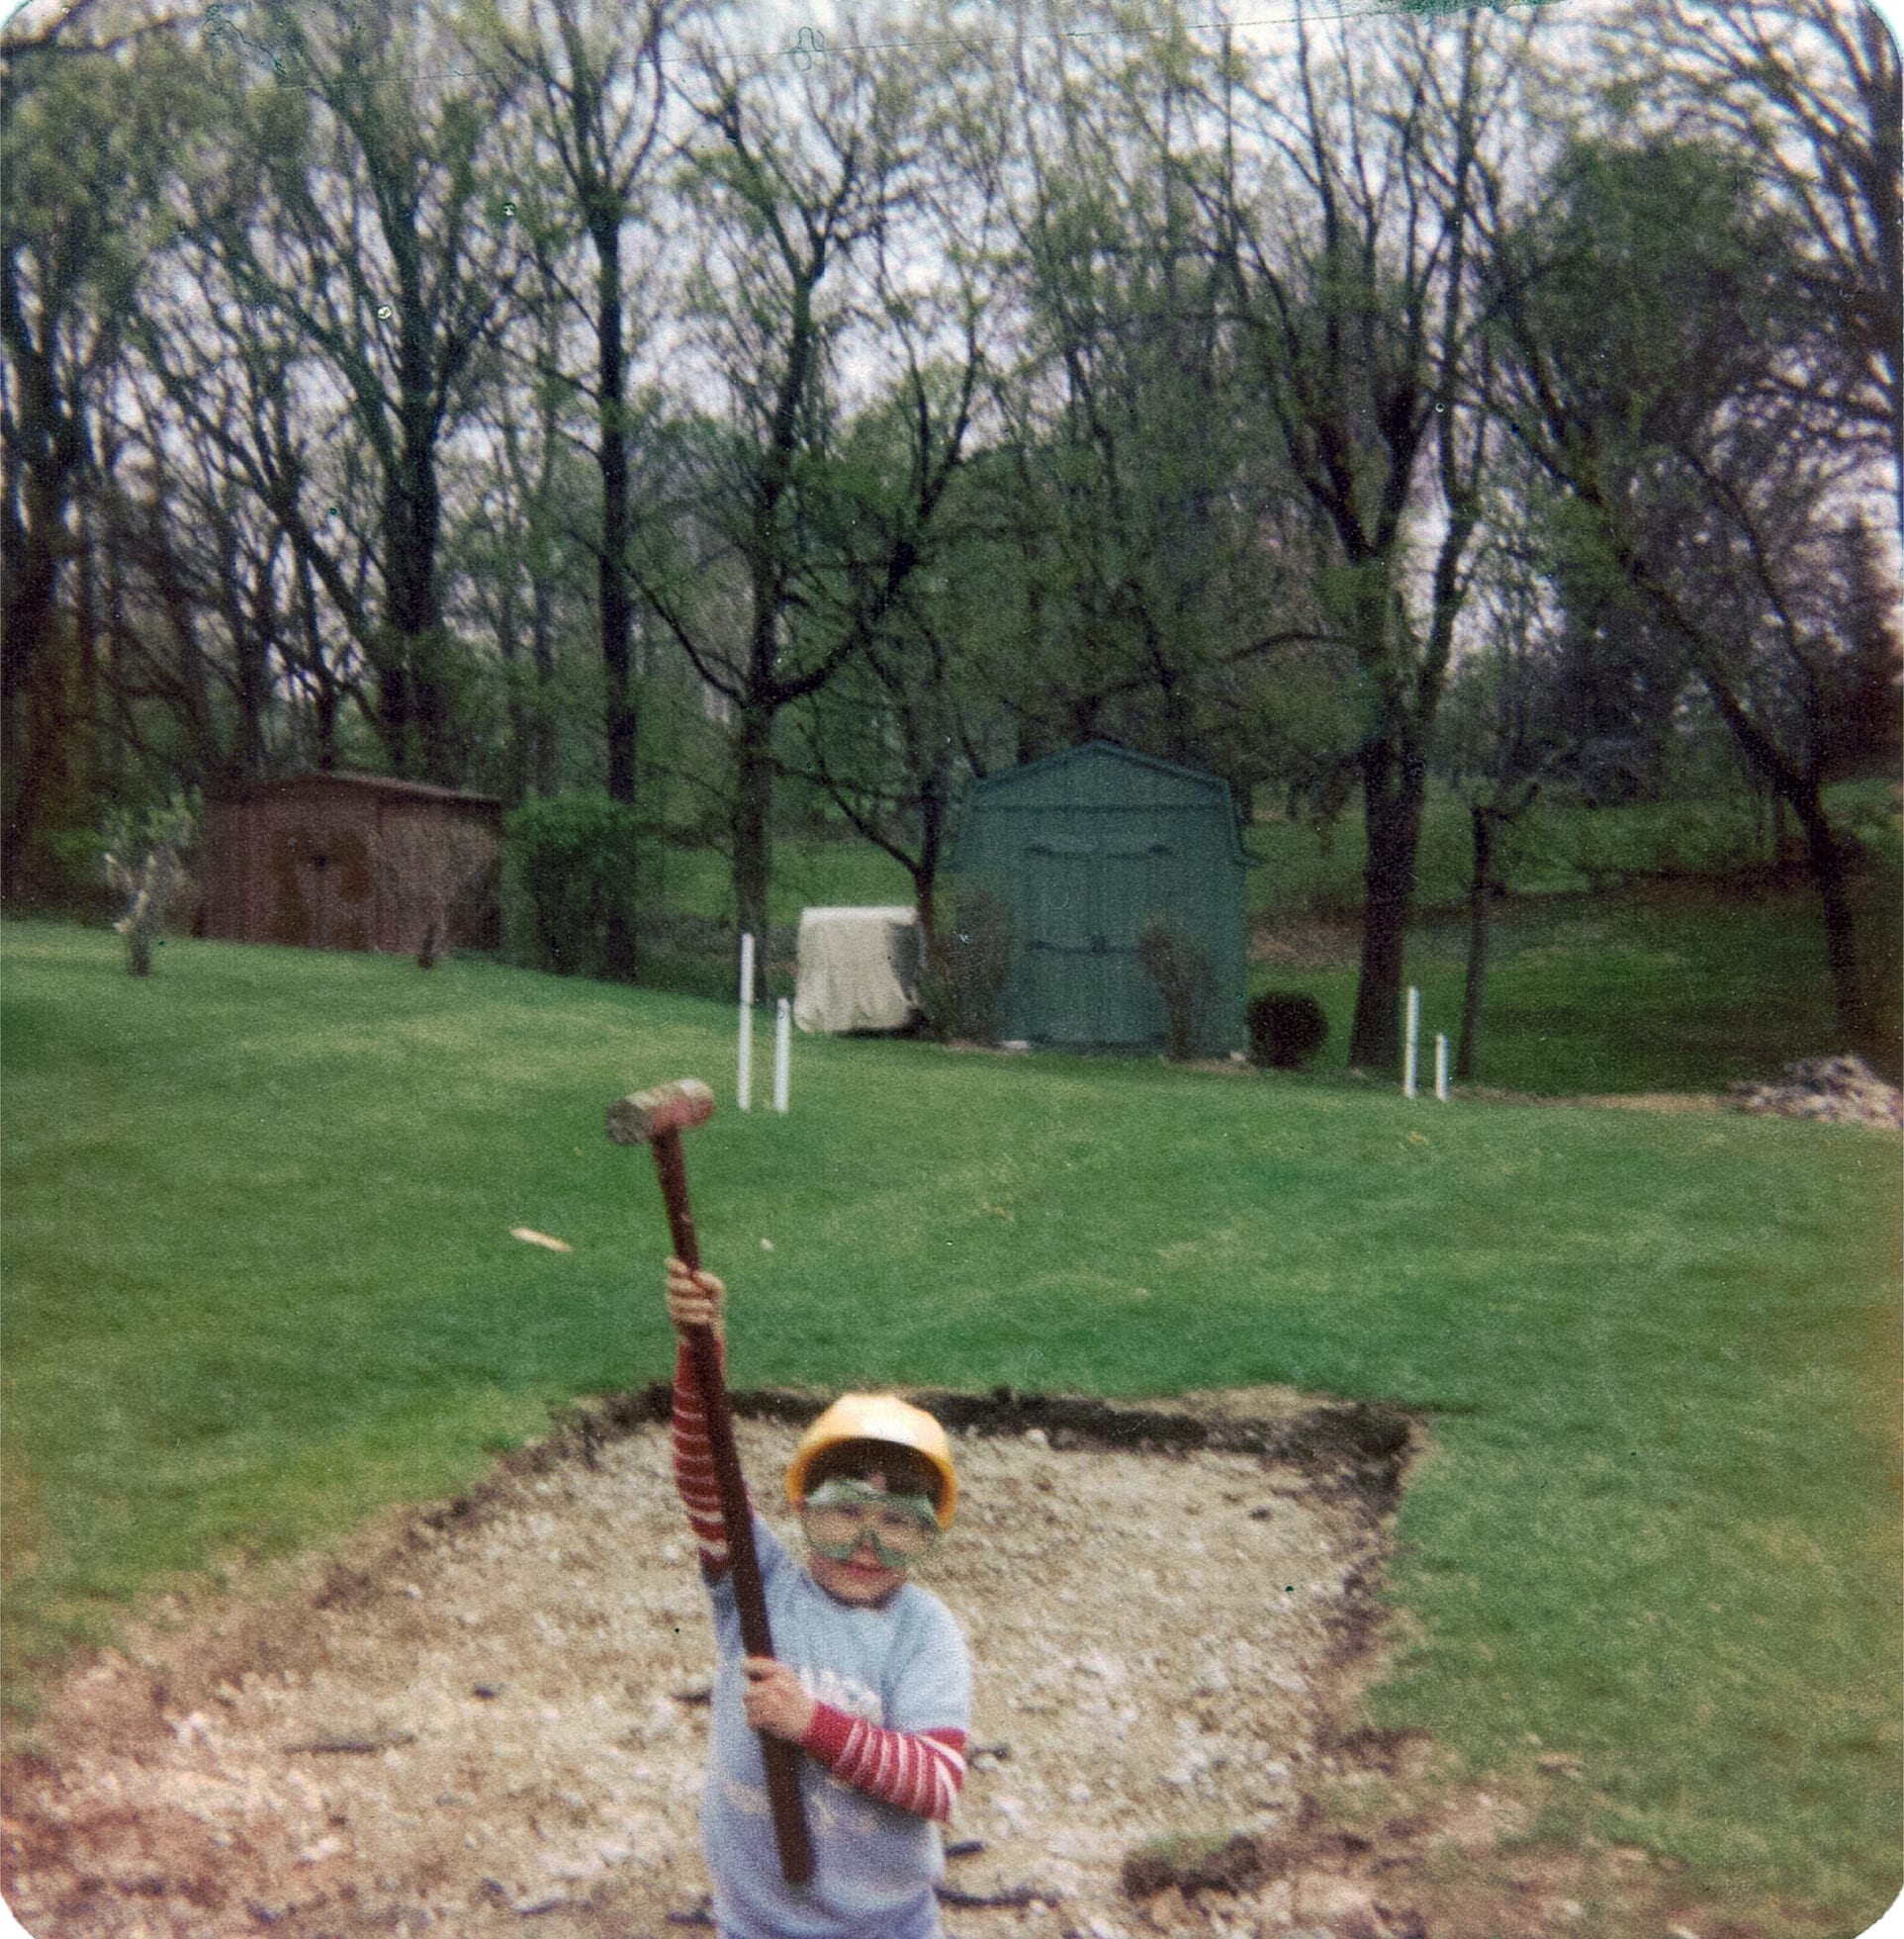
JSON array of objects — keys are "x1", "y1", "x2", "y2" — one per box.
[{"x1": 200, "y1": 774, "x2": 502, "y2": 954}]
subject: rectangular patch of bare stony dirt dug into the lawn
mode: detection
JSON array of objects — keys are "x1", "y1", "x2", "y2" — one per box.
[{"x1": 4, "y1": 1388, "x2": 1791, "y2": 1939}]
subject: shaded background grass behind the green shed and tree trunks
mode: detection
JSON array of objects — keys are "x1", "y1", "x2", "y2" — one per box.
[{"x1": 665, "y1": 784, "x2": 1904, "y2": 1095}]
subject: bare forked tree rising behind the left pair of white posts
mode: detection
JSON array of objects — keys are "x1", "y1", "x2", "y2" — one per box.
[{"x1": 640, "y1": 41, "x2": 963, "y2": 984}]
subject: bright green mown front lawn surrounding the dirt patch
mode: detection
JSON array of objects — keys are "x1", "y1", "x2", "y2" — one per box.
[{"x1": 0, "y1": 925, "x2": 1904, "y2": 1931}]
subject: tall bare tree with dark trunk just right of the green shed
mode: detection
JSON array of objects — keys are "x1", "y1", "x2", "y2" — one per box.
[{"x1": 1212, "y1": 0, "x2": 1524, "y2": 1068}]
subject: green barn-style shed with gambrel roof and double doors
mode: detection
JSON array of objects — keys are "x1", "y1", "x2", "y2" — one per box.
[{"x1": 952, "y1": 741, "x2": 1250, "y2": 1057}]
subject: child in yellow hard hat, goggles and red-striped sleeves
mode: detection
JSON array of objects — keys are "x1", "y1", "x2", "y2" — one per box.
[{"x1": 667, "y1": 1258, "x2": 971, "y2": 1939}]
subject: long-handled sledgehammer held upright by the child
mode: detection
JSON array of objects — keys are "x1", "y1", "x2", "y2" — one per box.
[{"x1": 609, "y1": 1078, "x2": 812, "y2": 1885}]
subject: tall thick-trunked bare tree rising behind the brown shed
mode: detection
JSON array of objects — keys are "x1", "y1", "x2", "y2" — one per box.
[{"x1": 184, "y1": 0, "x2": 519, "y2": 784}]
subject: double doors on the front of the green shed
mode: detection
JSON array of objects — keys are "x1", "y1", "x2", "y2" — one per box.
[{"x1": 1026, "y1": 836, "x2": 1179, "y2": 1045}]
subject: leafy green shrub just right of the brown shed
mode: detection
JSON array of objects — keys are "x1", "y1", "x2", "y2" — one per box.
[{"x1": 504, "y1": 795, "x2": 640, "y2": 977}]
